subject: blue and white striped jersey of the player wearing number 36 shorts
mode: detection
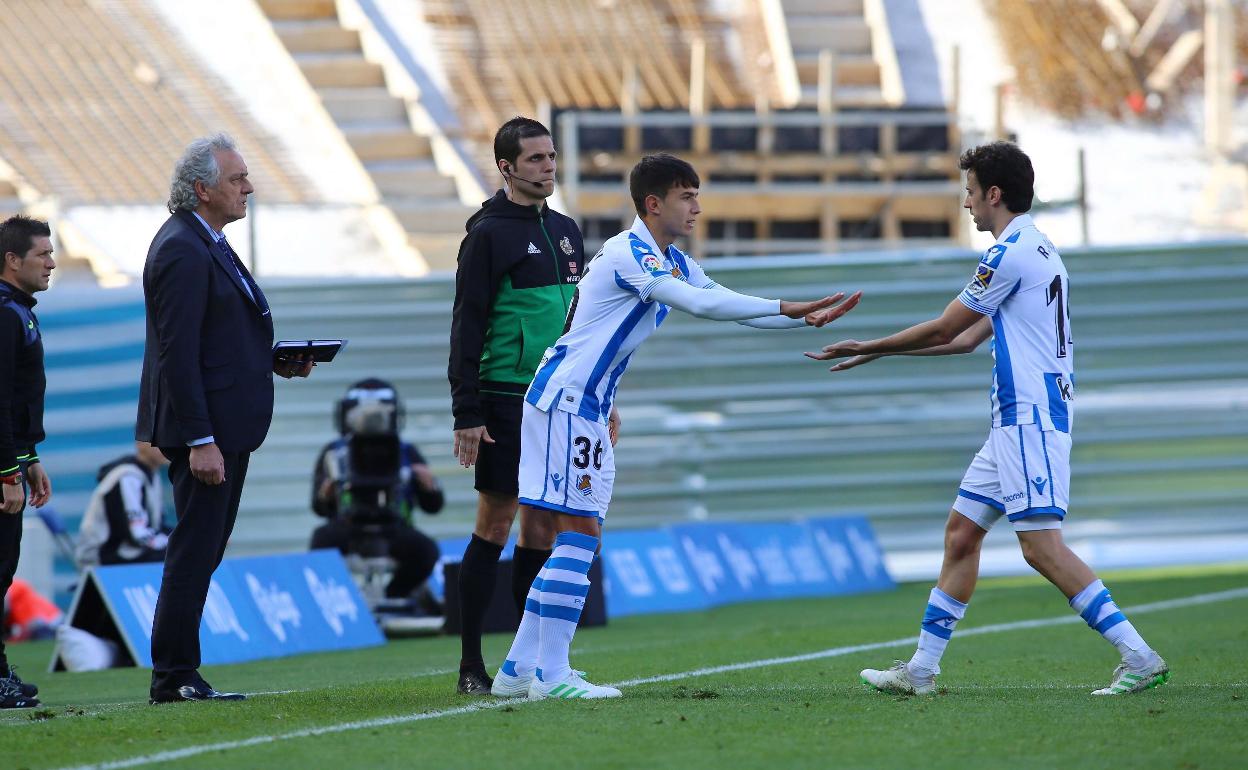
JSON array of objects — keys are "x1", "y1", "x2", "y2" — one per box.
[{"x1": 524, "y1": 217, "x2": 715, "y2": 423}]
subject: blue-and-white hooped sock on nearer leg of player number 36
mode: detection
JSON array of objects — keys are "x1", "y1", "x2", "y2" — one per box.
[{"x1": 538, "y1": 532, "x2": 598, "y2": 681}]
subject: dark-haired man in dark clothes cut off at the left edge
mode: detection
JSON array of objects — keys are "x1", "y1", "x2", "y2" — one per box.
[{"x1": 0, "y1": 216, "x2": 56, "y2": 709}]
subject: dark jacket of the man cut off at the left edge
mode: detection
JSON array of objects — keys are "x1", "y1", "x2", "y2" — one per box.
[{"x1": 0, "y1": 281, "x2": 47, "y2": 475}]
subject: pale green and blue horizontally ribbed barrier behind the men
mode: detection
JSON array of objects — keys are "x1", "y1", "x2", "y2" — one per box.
[{"x1": 40, "y1": 243, "x2": 1248, "y2": 581}]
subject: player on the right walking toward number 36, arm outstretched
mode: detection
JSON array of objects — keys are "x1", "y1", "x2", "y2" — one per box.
[{"x1": 806, "y1": 142, "x2": 1169, "y2": 695}]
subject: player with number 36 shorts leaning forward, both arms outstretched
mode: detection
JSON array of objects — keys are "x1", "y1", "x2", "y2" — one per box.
[{"x1": 493, "y1": 155, "x2": 860, "y2": 698}]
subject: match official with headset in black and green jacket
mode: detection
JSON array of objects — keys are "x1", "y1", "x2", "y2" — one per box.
[{"x1": 448, "y1": 117, "x2": 604, "y2": 695}]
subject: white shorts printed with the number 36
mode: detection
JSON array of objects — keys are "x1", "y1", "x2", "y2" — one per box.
[{"x1": 519, "y1": 402, "x2": 615, "y2": 519}]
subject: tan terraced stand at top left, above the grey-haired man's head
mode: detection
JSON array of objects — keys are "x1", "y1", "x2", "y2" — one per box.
[{"x1": 0, "y1": 0, "x2": 310, "y2": 206}]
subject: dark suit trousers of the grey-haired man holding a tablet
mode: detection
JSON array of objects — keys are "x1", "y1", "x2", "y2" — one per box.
[{"x1": 152, "y1": 447, "x2": 251, "y2": 690}]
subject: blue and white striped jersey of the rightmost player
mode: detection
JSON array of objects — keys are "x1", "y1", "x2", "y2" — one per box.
[{"x1": 958, "y1": 213, "x2": 1075, "y2": 433}]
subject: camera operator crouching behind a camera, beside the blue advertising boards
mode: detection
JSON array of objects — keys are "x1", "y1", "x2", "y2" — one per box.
[{"x1": 311, "y1": 378, "x2": 446, "y2": 604}]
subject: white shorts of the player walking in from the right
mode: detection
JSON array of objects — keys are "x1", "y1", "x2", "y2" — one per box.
[{"x1": 953, "y1": 424, "x2": 1071, "y2": 532}]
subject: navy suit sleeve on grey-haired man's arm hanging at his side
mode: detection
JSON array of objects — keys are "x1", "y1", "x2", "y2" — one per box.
[{"x1": 147, "y1": 236, "x2": 213, "y2": 442}]
